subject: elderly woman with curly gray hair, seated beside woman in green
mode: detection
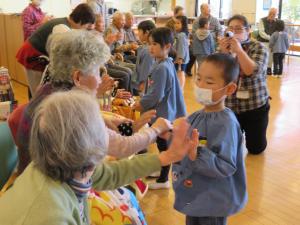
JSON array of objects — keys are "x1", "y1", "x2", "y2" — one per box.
[{"x1": 9, "y1": 30, "x2": 171, "y2": 174}]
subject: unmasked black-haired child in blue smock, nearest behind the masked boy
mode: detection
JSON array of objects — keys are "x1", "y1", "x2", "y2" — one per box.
[{"x1": 135, "y1": 27, "x2": 186, "y2": 189}]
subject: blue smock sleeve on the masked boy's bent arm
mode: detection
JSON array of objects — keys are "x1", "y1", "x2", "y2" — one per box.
[{"x1": 190, "y1": 124, "x2": 242, "y2": 178}]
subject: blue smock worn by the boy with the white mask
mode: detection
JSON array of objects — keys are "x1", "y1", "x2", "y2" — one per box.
[{"x1": 172, "y1": 108, "x2": 247, "y2": 217}]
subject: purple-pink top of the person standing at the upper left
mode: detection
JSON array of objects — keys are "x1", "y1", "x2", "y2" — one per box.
[{"x1": 22, "y1": 4, "x2": 45, "y2": 40}]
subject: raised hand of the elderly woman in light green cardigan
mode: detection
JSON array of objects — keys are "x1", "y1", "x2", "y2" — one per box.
[{"x1": 159, "y1": 118, "x2": 199, "y2": 166}]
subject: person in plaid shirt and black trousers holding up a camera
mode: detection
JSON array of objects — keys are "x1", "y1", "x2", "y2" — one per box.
[{"x1": 219, "y1": 15, "x2": 270, "y2": 154}]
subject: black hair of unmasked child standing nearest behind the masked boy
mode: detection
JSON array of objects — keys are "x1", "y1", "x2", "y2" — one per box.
[{"x1": 150, "y1": 27, "x2": 174, "y2": 48}]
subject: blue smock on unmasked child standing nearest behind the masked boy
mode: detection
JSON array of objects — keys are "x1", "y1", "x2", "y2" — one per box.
[{"x1": 140, "y1": 58, "x2": 186, "y2": 123}]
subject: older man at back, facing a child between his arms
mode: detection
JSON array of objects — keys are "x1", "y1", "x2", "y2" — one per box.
[{"x1": 192, "y1": 3, "x2": 222, "y2": 40}]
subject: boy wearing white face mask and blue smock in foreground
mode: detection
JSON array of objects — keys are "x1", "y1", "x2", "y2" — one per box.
[{"x1": 172, "y1": 54, "x2": 247, "y2": 225}]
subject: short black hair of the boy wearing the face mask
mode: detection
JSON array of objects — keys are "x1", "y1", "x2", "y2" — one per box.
[{"x1": 204, "y1": 53, "x2": 240, "y2": 84}]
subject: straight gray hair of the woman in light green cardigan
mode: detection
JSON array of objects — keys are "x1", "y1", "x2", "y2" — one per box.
[{"x1": 29, "y1": 90, "x2": 108, "y2": 181}]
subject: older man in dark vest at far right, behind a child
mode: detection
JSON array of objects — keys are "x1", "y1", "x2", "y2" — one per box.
[{"x1": 257, "y1": 8, "x2": 277, "y2": 75}]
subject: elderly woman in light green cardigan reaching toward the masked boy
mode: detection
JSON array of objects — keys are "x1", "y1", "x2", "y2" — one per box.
[{"x1": 0, "y1": 90, "x2": 198, "y2": 225}]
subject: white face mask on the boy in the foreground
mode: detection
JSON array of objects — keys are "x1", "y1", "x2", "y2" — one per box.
[{"x1": 194, "y1": 85, "x2": 227, "y2": 106}]
